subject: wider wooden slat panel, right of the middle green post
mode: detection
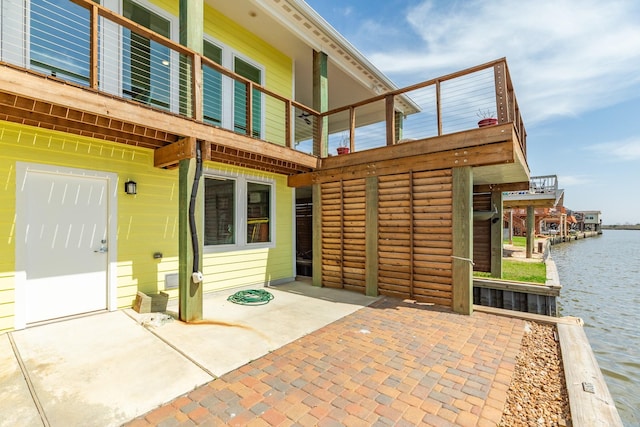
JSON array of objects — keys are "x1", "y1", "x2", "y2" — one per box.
[{"x1": 378, "y1": 170, "x2": 453, "y2": 307}]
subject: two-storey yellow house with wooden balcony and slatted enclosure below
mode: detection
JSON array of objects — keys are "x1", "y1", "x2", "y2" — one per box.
[{"x1": 0, "y1": 0, "x2": 529, "y2": 331}]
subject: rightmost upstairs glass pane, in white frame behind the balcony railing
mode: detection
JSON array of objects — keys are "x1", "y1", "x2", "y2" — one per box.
[{"x1": 233, "y1": 58, "x2": 262, "y2": 138}]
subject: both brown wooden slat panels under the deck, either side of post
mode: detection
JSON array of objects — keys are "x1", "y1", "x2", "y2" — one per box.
[{"x1": 320, "y1": 170, "x2": 453, "y2": 307}]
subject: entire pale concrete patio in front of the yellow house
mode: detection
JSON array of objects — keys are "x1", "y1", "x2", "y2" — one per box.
[{"x1": 0, "y1": 282, "x2": 377, "y2": 427}]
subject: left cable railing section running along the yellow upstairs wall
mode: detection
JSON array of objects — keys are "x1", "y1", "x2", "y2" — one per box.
[{"x1": 0, "y1": 0, "x2": 317, "y2": 147}]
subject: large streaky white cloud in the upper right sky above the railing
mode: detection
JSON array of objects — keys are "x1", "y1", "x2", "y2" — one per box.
[{"x1": 366, "y1": 0, "x2": 640, "y2": 123}]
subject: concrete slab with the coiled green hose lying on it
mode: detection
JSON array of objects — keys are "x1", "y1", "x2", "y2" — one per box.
[{"x1": 127, "y1": 282, "x2": 376, "y2": 376}]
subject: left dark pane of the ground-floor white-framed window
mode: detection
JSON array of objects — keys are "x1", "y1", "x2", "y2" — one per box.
[{"x1": 204, "y1": 178, "x2": 236, "y2": 246}]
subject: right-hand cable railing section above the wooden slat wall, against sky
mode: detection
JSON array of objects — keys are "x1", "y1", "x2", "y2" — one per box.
[{"x1": 321, "y1": 58, "x2": 526, "y2": 160}]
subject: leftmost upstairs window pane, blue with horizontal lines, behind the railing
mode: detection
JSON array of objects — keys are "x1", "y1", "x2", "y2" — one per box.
[{"x1": 29, "y1": 0, "x2": 90, "y2": 85}]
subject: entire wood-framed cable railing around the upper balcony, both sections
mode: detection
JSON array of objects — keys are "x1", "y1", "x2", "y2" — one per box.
[{"x1": 1, "y1": 0, "x2": 526, "y2": 160}]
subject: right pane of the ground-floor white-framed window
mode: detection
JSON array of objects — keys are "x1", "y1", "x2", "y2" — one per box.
[{"x1": 247, "y1": 182, "x2": 271, "y2": 243}]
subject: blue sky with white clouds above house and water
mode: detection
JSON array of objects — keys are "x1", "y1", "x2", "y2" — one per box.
[{"x1": 306, "y1": 0, "x2": 640, "y2": 224}]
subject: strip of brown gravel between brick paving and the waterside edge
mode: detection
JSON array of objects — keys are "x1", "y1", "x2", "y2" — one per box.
[{"x1": 500, "y1": 322, "x2": 571, "y2": 427}]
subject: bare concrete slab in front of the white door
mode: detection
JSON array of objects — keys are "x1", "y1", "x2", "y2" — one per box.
[{"x1": 5, "y1": 311, "x2": 213, "y2": 426}]
